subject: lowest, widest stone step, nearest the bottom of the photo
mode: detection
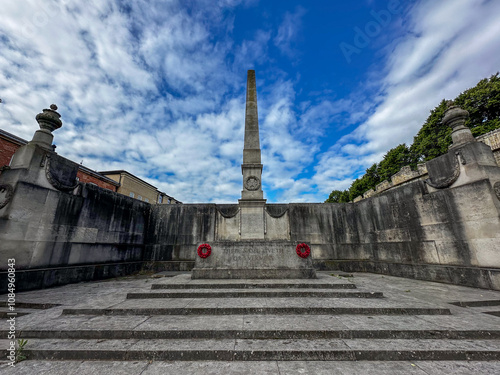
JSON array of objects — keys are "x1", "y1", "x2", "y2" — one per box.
[{"x1": 13, "y1": 339, "x2": 500, "y2": 361}]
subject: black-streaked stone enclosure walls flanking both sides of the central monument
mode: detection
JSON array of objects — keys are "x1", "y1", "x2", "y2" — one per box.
[{"x1": 0, "y1": 176, "x2": 500, "y2": 289}]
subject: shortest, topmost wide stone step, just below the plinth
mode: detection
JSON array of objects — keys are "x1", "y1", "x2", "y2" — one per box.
[{"x1": 151, "y1": 282, "x2": 356, "y2": 289}]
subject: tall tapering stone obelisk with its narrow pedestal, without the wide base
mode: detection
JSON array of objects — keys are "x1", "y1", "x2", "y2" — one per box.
[{"x1": 239, "y1": 70, "x2": 266, "y2": 240}]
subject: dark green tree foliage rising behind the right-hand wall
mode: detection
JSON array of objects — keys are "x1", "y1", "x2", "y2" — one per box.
[{"x1": 325, "y1": 73, "x2": 500, "y2": 203}]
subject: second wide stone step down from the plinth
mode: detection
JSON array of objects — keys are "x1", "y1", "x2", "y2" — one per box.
[{"x1": 127, "y1": 289, "x2": 383, "y2": 299}]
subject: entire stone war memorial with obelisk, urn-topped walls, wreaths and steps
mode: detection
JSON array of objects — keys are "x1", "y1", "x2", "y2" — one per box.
[{"x1": 0, "y1": 70, "x2": 500, "y2": 375}]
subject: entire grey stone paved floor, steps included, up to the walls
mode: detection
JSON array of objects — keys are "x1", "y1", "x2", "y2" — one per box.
[{"x1": 0, "y1": 273, "x2": 500, "y2": 375}]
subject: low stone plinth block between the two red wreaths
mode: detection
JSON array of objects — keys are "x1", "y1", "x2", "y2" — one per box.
[{"x1": 191, "y1": 240, "x2": 316, "y2": 279}]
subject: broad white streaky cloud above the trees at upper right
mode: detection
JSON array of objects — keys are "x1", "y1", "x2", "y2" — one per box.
[{"x1": 312, "y1": 0, "x2": 500, "y2": 201}]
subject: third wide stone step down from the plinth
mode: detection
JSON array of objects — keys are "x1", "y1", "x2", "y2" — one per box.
[{"x1": 62, "y1": 306, "x2": 451, "y2": 316}]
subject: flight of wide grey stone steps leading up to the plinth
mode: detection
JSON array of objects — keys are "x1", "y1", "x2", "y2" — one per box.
[{"x1": 5, "y1": 275, "x2": 500, "y2": 371}]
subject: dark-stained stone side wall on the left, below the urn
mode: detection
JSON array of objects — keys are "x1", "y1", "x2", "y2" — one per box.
[{"x1": 0, "y1": 181, "x2": 150, "y2": 290}]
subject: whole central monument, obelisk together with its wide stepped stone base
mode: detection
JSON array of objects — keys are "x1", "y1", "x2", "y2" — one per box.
[{"x1": 191, "y1": 70, "x2": 316, "y2": 279}]
